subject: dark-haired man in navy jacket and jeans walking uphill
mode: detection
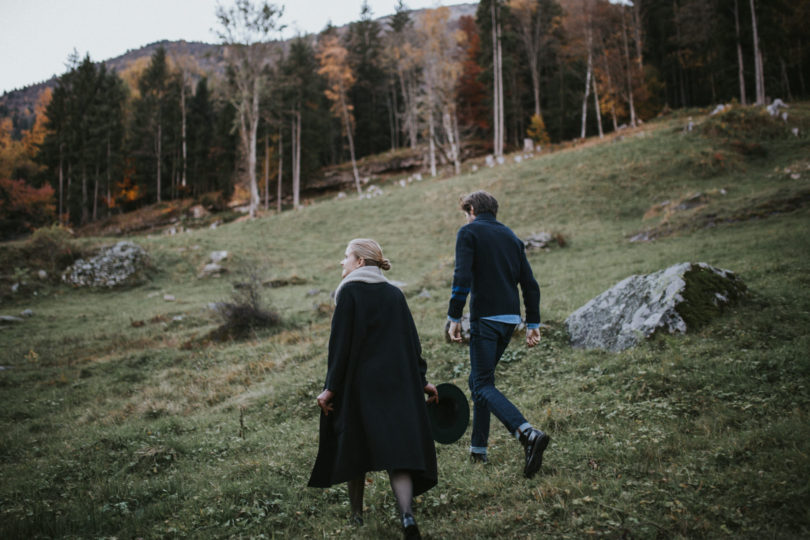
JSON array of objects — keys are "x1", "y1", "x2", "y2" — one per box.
[{"x1": 447, "y1": 191, "x2": 550, "y2": 478}]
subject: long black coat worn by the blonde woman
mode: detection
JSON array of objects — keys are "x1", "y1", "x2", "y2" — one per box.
[{"x1": 309, "y1": 282, "x2": 437, "y2": 495}]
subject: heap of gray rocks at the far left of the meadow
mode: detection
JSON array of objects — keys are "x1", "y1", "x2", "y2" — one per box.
[{"x1": 62, "y1": 241, "x2": 149, "y2": 288}]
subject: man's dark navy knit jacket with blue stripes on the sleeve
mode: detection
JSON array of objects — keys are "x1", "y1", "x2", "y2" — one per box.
[{"x1": 447, "y1": 212, "x2": 540, "y2": 324}]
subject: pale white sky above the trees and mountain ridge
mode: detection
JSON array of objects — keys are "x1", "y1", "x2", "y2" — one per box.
[{"x1": 0, "y1": 0, "x2": 454, "y2": 95}]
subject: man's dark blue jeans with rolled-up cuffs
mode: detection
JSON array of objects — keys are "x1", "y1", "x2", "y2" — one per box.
[{"x1": 470, "y1": 319, "x2": 526, "y2": 448}]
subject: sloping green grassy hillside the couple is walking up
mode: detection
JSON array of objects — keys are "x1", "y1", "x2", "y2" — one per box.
[{"x1": 0, "y1": 105, "x2": 810, "y2": 538}]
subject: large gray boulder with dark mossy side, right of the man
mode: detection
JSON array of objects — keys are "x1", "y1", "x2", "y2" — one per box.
[{"x1": 565, "y1": 263, "x2": 746, "y2": 351}]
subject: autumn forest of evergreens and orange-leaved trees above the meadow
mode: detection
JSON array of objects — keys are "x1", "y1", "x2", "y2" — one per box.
[{"x1": 0, "y1": 0, "x2": 810, "y2": 238}]
